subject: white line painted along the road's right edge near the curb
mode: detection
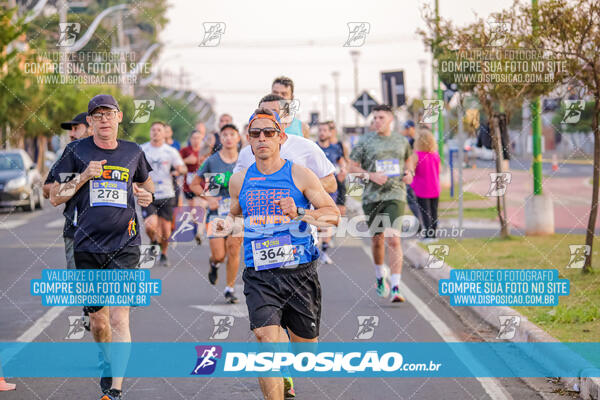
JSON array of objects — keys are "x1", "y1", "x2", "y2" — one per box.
[{"x1": 362, "y1": 244, "x2": 512, "y2": 400}]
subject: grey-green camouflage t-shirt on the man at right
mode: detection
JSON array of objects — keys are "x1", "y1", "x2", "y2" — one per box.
[{"x1": 350, "y1": 132, "x2": 412, "y2": 204}]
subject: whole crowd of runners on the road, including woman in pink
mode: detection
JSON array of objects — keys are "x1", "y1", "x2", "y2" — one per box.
[{"x1": 44, "y1": 77, "x2": 439, "y2": 400}]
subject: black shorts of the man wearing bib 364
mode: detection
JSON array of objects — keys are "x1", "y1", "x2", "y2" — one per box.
[{"x1": 242, "y1": 260, "x2": 321, "y2": 339}]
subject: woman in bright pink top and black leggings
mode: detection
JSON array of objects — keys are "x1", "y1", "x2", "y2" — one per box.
[{"x1": 410, "y1": 130, "x2": 440, "y2": 239}]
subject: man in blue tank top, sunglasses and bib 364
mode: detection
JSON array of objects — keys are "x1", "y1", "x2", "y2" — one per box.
[{"x1": 215, "y1": 109, "x2": 340, "y2": 399}]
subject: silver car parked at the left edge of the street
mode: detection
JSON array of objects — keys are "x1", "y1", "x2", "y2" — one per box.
[{"x1": 0, "y1": 150, "x2": 44, "y2": 211}]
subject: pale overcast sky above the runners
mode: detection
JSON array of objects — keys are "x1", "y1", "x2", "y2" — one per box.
[{"x1": 157, "y1": 0, "x2": 512, "y2": 127}]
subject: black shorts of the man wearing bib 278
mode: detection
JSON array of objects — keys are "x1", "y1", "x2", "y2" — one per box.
[{"x1": 75, "y1": 246, "x2": 140, "y2": 313}]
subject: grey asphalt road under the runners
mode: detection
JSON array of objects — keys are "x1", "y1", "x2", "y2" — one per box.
[{"x1": 0, "y1": 205, "x2": 562, "y2": 400}]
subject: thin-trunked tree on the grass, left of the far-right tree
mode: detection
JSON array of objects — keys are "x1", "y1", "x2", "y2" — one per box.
[{"x1": 419, "y1": 1, "x2": 560, "y2": 237}]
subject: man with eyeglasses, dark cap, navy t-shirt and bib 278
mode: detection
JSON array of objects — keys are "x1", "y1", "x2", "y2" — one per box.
[{"x1": 50, "y1": 94, "x2": 154, "y2": 400}]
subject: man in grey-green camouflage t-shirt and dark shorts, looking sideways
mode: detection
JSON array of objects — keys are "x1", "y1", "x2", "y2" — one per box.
[{"x1": 350, "y1": 105, "x2": 415, "y2": 303}]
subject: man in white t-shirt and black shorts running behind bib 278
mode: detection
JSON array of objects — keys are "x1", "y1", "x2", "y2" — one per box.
[{"x1": 141, "y1": 121, "x2": 187, "y2": 267}]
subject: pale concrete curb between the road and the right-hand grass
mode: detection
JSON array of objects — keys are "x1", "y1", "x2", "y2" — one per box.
[{"x1": 402, "y1": 240, "x2": 600, "y2": 400}]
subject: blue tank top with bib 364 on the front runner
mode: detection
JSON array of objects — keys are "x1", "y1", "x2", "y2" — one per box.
[{"x1": 239, "y1": 160, "x2": 319, "y2": 270}]
